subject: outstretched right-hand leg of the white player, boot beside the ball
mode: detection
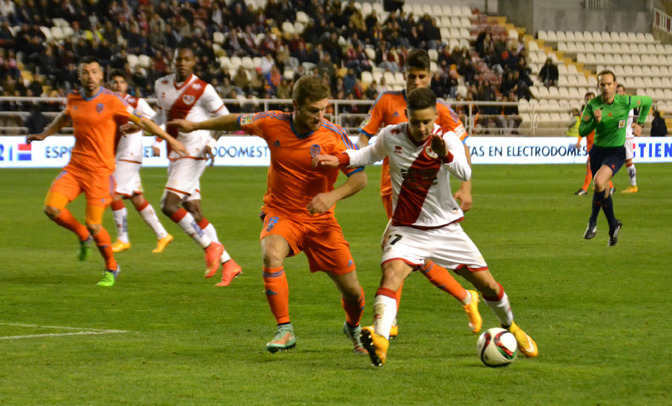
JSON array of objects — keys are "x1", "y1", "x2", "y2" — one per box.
[{"x1": 455, "y1": 266, "x2": 539, "y2": 358}]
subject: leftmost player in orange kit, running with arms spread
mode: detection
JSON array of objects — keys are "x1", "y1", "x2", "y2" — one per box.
[{"x1": 26, "y1": 56, "x2": 186, "y2": 286}]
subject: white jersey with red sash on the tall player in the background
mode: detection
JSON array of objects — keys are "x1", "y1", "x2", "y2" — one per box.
[{"x1": 154, "y1": 74, "x2": 229, "y2": 159}]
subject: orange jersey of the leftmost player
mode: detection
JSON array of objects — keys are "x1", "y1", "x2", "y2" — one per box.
[{"x1": 65, "y1": 87, "x2": 134, "y2": 173}]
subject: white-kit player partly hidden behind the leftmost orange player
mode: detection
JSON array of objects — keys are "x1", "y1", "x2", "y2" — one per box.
[{"x1": 108, "y1": 69, "x2": 173, "y2": 253}]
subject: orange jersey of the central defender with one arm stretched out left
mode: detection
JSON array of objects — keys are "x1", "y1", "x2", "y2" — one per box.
[{"x1": 238, "y1": 111, "x2": 363, "y2": 218}]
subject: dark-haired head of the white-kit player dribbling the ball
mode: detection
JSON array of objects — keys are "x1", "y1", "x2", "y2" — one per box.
[{"x1": 406, "y1": 87, "x2": 438, "y2": 141}]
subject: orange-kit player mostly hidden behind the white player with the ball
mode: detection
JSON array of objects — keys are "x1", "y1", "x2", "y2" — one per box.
[{"x1": 358, "y1": 49, "x2": 483, "y2": 338}]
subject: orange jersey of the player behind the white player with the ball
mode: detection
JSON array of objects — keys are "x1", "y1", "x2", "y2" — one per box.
[{"x1": 359, "y1": 90, "x2": 469, "y2": 196}]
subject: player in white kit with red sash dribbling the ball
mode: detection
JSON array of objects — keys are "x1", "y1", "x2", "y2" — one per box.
[{"x1": 314, "y1": 88, "x2": 538, "y2": 366}]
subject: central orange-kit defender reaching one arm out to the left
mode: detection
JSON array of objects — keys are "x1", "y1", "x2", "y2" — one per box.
[{"x1": 168, "y1": 76, "x2": 367, "y2": 354}]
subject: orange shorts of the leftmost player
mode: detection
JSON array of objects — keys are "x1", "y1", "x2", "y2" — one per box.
[{"x1": 49, "y1": 167, "x2": 114, "y2": 207}]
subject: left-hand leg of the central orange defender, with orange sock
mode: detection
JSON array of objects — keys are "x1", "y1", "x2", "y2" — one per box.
[{"x1": 261, "y1": 230, "x2": 296, "y2": 353}]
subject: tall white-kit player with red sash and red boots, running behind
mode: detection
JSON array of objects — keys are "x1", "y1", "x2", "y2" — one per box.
[{"x1": 154, "y1": 43, "x2": 241, "y2": 286}]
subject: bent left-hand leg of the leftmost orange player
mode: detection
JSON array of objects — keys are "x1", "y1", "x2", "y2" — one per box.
[{"x1": 44, "y1": 171, "x2": 93, "y2": 261}]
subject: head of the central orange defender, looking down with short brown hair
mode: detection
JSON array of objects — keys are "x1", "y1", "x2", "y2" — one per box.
[{"x1": 292, "y1": 75, "x2": 331, "y2": 133}]
